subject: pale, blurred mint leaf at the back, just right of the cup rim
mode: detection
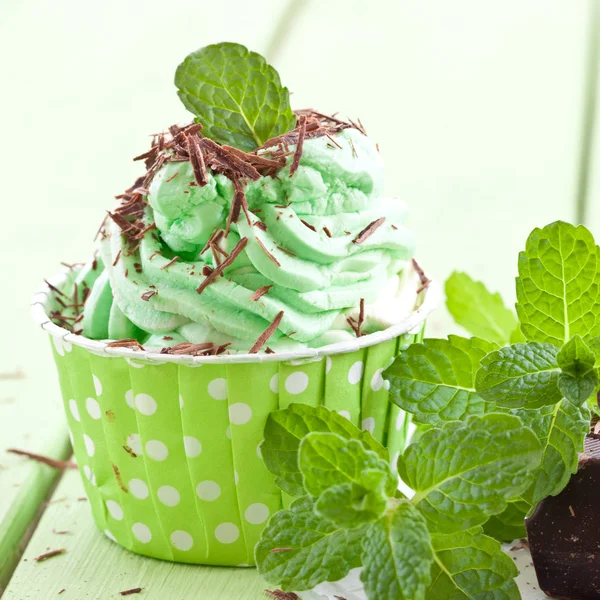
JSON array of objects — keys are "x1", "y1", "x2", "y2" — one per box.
[{"x1": 446, "y1": 271, "x2": 518, "y2": 346}]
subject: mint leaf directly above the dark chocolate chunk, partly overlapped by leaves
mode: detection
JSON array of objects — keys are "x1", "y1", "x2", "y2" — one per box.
[{"x1": 515, "y1": 400, "x2": 590, "y2": 504}]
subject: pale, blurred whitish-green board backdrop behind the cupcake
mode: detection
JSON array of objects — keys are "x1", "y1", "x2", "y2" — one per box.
[{"x1": 0, "y1": 0, "x2": 600, "y2": 598}]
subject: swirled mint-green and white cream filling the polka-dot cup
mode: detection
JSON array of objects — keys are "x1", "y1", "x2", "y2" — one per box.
[{"x1": 61, "y1": 128, "x2": 419, "y2": 351}]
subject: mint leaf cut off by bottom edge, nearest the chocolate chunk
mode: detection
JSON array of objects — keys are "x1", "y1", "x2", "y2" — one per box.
[{"x1": 426, "y1": 531, "x2": 521, "y2": 600}]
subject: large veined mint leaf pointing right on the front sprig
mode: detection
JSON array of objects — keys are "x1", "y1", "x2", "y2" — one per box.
[{"x1": 398, "y1": 413, "x2": 542, "y2": 533}]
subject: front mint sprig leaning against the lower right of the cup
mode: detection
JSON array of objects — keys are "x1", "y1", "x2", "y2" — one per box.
[{"x1": 256, "y1": 404, "x2": 542, "y2": 600}]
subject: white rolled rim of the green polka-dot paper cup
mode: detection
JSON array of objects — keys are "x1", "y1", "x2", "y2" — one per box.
[{"x1": 31, "y1": 271, "x2": 442, "y2": 366}]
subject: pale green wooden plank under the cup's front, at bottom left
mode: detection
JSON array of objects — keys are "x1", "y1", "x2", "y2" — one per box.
[{"x1": 3, "y1": 471, "x2": 265, "y2": 600}]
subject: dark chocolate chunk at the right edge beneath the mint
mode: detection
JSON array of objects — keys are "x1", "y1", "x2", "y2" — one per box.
[{"x1": 525, "y1": 435, "x2": 600, "y2": 600}]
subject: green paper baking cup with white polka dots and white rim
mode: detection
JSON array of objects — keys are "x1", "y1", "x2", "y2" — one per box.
[{"x1": 32, "y1": 278, "x2": 440, "y2": 566}]
